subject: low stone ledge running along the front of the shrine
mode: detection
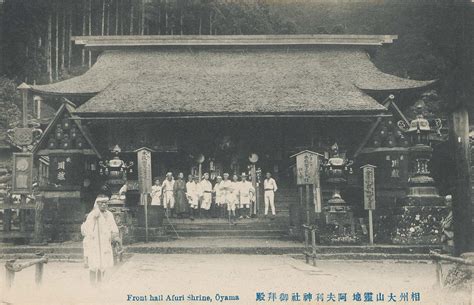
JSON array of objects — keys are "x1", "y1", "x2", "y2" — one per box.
[{"x1": 0, "y1": 237, "x2": 439, "y2": 262}]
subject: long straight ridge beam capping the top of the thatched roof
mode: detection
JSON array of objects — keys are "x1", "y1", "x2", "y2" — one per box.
[{"x1": 71, "y1": 34, "x2": 398, "y2": 50}]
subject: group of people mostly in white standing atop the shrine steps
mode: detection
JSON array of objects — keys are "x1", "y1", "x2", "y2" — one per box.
[{"x1": 151, "y1": 172, "x2": 277, "y2": 222}]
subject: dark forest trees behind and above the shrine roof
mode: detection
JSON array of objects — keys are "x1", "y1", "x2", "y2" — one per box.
[{"x1": 2, "y1": 0, "x2": 462, "y2": 115}]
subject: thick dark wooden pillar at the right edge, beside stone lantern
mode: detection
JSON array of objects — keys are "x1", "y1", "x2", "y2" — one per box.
[{"x1": 451, "y1": 107, "x2": 473, "y2": 256}]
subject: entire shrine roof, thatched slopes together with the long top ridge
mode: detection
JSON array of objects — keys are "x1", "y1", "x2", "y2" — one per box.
[{"x1": 31, "y1": 35, "x2": 433, "y2": 119}]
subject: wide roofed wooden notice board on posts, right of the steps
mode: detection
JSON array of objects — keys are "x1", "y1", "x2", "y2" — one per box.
[{"x1": 291, "y1": 150, "x2": 322, "y2": 225}]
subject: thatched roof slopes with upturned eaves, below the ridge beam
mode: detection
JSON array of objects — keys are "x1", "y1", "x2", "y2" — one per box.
[{"x1": 33, "y1": 46, "x2": 432, "y2": 115}]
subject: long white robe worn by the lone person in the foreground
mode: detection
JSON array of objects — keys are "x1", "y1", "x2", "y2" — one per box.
[{"x1": 81, "y1": 204, "x2": 119, "y2": 271}]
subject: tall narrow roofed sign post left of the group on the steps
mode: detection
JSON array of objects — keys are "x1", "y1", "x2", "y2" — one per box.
[{"x1": 135, "y1": 147, "x2": 153, "y2": 242}]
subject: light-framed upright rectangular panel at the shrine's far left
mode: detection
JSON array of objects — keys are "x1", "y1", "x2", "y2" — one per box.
[{"x1": 12, "y1": 153, "x2": 33, "y2": 194}]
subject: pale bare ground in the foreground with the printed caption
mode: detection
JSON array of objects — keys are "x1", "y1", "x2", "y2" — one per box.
[{"x1": 0, "y1": 254, "x2": 472, "y2": 305}]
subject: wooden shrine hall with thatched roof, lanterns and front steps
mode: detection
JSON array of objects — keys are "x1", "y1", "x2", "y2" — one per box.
[{"x1": 7, "y1": 35, "x2": 447, "y2": 244}]
